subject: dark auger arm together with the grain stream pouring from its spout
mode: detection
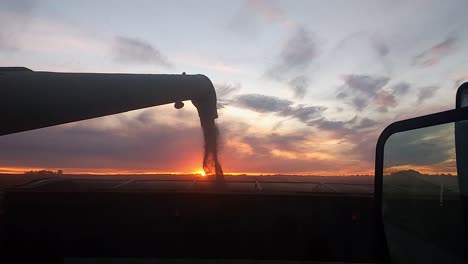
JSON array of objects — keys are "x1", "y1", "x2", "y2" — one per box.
[{"x1": 0, "y1": 67, "x2": 224, "y2": 185}]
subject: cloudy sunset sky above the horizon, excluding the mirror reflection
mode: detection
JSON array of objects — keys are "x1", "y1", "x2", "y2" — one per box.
[{"x1": 0, "y1": 0, "x2": 468, "y2": 175}]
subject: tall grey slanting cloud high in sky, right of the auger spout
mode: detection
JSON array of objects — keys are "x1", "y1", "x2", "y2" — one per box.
[{"x1": 266, "y1": 27, "x2": 317, "y2": 80}]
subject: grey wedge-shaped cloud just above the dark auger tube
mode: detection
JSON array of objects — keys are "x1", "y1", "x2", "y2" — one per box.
[{"x1": 113, "y1": 36, "x2": 173, "y2": 68}]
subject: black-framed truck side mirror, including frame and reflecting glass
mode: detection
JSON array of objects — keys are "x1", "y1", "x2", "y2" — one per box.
[{"x1": 375, "y1": 84, "x2": 468, "y2": 263}]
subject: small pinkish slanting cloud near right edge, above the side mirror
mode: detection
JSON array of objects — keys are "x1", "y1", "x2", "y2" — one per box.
[{"x1": 413, "y1": 35, "x2": 458, "y2": 67}]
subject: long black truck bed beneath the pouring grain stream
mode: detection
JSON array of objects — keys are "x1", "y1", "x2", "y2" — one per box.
[{"x1": 5, "y1": 177, "x2": 377, "y2": 262}]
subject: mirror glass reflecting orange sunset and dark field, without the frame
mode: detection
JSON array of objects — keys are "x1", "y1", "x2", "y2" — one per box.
[{"x1": 382, "y1": 123, "x2": 465, "y2": 263}]
